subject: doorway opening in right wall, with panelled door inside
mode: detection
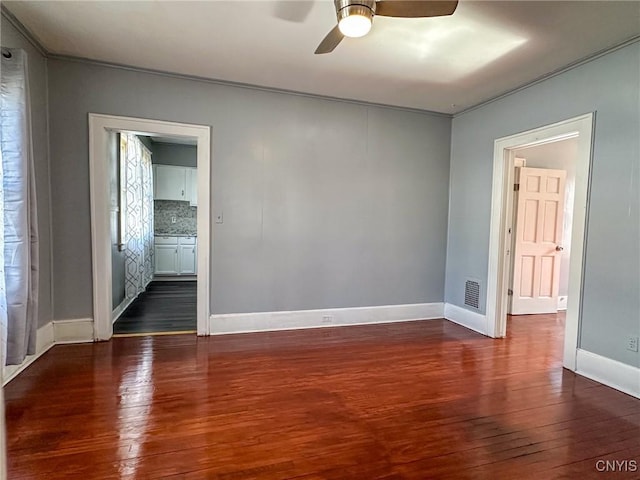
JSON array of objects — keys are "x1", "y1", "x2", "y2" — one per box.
[{"x1": 507, "y1": 136, "x2": 578, "y2": 315}]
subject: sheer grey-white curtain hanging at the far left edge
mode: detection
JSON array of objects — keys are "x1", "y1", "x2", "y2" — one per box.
[{"x1": 0, "y1": 48, "x2": 38, "y2": 365}]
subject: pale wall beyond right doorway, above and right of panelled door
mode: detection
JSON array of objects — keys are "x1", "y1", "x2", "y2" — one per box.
[{"x1": 516, "y1": 138, "x2": 578, "y2": 297}]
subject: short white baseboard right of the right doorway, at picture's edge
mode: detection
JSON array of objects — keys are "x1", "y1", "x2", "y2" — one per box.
[{"x1": 576, "y1": 348, "x2": 640, "y2": 398}]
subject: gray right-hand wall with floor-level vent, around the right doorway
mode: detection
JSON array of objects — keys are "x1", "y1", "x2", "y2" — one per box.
[{"x1": 445, "y1": 42, "x2": 640, "y2": 366}]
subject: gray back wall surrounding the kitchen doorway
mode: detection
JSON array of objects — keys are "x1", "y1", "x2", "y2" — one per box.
[{"x1": 49, "y1": 59, "x2": 451, "y2": 319}]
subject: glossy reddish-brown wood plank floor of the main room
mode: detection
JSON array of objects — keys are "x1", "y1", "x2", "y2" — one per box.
[{"x1": 5, "y1": 315, "x2": 640, "y2": 480}]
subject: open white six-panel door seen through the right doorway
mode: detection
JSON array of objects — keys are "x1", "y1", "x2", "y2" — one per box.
[{"x1": 511, "y1": 167, "x2": 566, "y2": 315}]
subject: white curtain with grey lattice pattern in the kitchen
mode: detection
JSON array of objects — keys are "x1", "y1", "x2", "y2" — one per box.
[{"x1": 120, "y1": 132, "x2": 154, "y2": 299}]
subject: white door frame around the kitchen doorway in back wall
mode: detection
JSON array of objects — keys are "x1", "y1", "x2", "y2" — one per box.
[{"x1": 89, "y1": 113, "x2": 212, "y2": 340}]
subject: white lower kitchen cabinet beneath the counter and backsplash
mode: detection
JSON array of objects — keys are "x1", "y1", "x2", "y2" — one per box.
[{"x1": 155, "y1": 235, "x2": 197, "y2": 275}]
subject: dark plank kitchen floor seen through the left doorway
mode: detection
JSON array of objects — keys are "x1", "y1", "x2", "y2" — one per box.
[{"x1": 113, "y1": 281, "x2": 197, "y2": 334}]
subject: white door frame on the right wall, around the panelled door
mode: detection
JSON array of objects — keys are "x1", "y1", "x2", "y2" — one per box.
[{"x1": 486, "y1": 113, "x2": 595, "y2": 371}]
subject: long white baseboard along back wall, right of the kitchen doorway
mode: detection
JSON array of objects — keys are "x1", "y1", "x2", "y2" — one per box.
[{"x1": 209, "y1": 303, "x2": 443, "y2": 335}]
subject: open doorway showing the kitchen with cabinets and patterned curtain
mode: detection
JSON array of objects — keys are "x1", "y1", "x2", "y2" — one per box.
[{"x1": 109, "y1": 131, "x2": 198, "y2": 336}]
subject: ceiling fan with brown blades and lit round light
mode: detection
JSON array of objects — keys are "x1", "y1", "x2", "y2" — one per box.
[{"x1": 314, "y1": 0, "x2": 458, "y2": 54}]
